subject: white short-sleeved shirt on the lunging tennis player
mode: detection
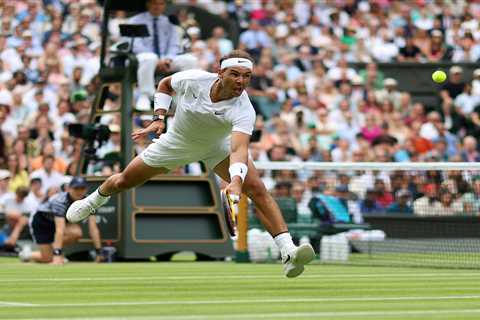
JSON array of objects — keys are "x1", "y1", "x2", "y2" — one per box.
[{"x1": 166, "y1": 70, "x2": 255, "y2": 147}]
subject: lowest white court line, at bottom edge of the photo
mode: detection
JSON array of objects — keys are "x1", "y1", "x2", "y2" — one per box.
[{"x1": 11, "y1": 309, "x2": 480, "y2": 320}]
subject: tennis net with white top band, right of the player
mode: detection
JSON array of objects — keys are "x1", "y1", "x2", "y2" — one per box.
[{"x1": 250, "y1": 162, "x2": 480, "y2": 268}]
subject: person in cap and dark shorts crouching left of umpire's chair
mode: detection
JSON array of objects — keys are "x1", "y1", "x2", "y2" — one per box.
[{"x1": 19, "y1": 177, "x2": 102, "y2": 264}]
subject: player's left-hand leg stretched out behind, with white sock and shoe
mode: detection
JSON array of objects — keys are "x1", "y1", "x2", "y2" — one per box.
[{"x1": 67, "y1": 156, "x2": 169, "y2": 223}]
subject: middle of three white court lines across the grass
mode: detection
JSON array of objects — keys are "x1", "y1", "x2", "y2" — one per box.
[{"x1": 0, "y1": 295, "x2": 480, "y2": 308}]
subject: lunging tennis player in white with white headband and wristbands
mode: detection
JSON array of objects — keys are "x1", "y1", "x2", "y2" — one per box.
[{"x1": 67, "y1": 50, "x2": 314, "y2": 278}]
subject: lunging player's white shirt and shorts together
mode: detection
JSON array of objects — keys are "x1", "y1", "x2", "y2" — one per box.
[{"x1": 141, "y1": 70, "x2": 255, "y2": 169}]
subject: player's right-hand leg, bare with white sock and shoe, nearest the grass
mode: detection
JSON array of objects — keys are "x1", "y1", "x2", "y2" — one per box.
[{"x1": 215, "y1": 158, "x2": 315, "y2": 278}]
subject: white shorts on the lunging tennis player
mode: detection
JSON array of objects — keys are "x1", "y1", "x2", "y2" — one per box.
[{"x1": 140, "y1": 133, "x2": 230, "y2": 170}]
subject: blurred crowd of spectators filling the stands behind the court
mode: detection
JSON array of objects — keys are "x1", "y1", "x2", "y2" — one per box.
[{"x1": 0, "y1": 0, "x2": 480, "y2": 248}]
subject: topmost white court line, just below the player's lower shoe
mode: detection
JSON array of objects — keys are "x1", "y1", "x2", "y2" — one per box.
[{"x1": 0, "y1": 272, "x2": 480, "y2": 283}]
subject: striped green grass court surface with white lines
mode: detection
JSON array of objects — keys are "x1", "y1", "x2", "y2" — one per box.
[{"x1": 0, "y1": 258, "x2": 480, "y2": 320}]
